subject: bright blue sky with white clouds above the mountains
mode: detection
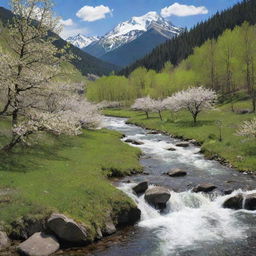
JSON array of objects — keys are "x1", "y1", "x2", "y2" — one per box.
[{"x1": 0, "y1": 0, "x2": 240, "y2": 37}]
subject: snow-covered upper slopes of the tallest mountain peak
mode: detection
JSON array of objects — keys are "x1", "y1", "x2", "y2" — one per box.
[{"x1": 99, "y1": 12, "x2": 181, "y2": 52}]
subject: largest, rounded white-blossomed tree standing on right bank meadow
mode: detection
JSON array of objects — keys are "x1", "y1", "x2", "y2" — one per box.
[{"x1": 169, "y1": 87, "x2": 217, "y2": 123}]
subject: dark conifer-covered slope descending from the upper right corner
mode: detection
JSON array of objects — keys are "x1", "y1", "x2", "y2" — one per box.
[{"x1": 119, "y1": 0, "x2": 256, "y2": 75}]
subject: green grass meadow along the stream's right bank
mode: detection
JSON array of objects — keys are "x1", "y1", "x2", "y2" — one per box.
[{"x1": 105, "y1": 101, "x2": 256, "y2": 171}]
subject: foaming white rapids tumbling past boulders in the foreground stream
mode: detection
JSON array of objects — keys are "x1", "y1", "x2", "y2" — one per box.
[{"x1": 119, "y1": 184, "x2": 256, "y2": 256}]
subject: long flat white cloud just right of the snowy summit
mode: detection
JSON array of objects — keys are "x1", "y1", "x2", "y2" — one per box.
[{"x1": 161, "y1": 3, "x2": 208, "y2": 18}]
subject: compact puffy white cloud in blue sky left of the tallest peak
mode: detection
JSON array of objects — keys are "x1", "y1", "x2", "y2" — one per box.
[{"x1": 76, "y1": 5, "x2": 112, "y2": 22}]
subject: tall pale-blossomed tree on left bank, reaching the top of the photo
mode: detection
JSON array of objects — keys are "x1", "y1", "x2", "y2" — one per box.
[{"x1": 0, "y1": 0, "x2": 101, "y2": 150}]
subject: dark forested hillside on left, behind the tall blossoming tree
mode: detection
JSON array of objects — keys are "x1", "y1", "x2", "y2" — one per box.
[{"x1": 0, "y1": 7, "x2": 118, "y2": 76}]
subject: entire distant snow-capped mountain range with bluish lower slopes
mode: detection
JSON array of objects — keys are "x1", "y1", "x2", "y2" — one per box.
[{"x1": 68, "y1": 12, "x2": 183, "y2": 66}]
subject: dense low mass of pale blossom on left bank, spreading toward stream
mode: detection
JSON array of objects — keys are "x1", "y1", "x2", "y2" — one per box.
[{"x1": 3, "y1": 84, "x2": 101, "y2": 151}]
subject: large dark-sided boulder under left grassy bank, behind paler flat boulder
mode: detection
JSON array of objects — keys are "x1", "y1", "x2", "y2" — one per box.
[{"x1": 47, "y1": 213, "x2": 87, "y2": 244}]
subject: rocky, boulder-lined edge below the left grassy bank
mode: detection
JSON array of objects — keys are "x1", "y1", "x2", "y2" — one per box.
[{"x1": 0, "y1": 205, "x2": 141, "y2": 256}]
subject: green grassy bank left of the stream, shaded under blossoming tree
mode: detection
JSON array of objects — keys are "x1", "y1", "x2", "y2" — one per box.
[{"x1": 0, "y1": 120, "x2": 142, "y2": 238}]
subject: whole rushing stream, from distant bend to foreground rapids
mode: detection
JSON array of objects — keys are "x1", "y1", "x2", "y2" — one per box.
[{"x1": 58, "y1": 117, "x2": 256, "y2": 256}]
